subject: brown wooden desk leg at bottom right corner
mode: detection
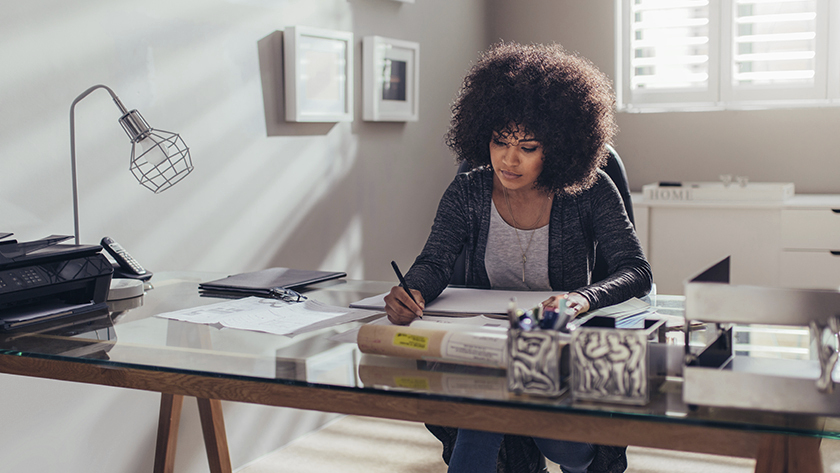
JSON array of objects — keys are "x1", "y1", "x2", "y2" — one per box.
[{"x1": 755, "y1": 434, "x2": 823, "y2": 473}]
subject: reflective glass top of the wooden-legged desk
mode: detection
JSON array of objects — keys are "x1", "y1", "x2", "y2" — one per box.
[{"x1": 0, "y1": 272, "x2": 840, "y2": 438}]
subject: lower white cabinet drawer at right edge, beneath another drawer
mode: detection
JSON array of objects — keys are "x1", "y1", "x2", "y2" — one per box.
[{"x1": 779, "y1": 250, "x2": 840, "y2": 290}]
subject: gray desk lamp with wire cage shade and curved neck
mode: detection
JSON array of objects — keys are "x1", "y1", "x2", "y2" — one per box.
[{"x1": 70, "y1": 85, "x2": 193, "y2": 245}]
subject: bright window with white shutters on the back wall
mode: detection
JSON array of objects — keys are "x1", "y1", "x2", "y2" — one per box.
[{"x1": 616, "y1": 0, "x2": 840, "y2": 111}]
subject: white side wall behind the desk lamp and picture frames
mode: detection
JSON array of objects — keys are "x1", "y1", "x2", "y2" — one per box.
[{"x1": 0, "y1": 0, "x2": 487, "y2": 472}]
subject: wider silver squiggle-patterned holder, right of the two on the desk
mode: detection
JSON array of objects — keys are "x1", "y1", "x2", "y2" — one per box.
[{"x1": 571, "y1": 317, "x2": 665, "y2": 405}]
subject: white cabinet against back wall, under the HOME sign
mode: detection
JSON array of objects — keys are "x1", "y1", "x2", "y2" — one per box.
[{"x1": 633, "y1": 194, "x2": 840, "y2": 294}]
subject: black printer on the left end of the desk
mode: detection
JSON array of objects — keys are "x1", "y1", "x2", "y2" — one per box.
[{"x1": 0, "y1": 234, "x2": 114, "y2": 330}]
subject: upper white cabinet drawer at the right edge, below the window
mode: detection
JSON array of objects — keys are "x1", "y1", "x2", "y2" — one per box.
[{"x1": 782, "y1": 208, "x2": 840, "y2": 250}]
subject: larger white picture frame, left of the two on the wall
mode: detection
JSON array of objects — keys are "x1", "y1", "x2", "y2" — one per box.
[{"x1": 283, "y1": 26, "x2": 354, "y2": 122}]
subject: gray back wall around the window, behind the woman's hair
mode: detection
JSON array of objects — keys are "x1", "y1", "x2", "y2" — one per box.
[{"x1": 490, "y1": 0, "x2": 840, "y2": 193}]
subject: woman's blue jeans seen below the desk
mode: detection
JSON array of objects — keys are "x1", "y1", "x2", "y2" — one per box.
[{"x1": 448, "y1": 429, "x2": 595, "y2": 473}]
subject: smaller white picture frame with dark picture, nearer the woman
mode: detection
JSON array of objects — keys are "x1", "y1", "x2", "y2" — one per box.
[{"x1": 362, "y1": 36, "x2": 420, "y2": 122}]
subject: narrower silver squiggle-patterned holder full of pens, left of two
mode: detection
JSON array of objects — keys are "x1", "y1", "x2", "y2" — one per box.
[{"x1": 507, "y1": 328, "x2": 566, "y2": 396}]
